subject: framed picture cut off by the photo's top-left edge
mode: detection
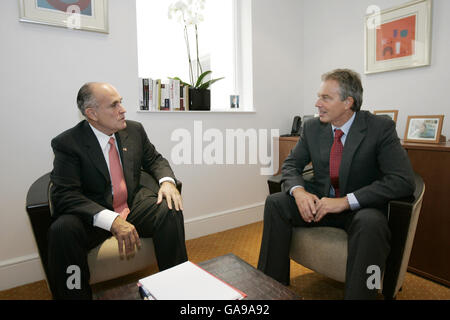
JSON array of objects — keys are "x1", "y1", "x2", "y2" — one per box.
[{"x1": 18, "y1": 0, "x2": 109, "y2": 33}]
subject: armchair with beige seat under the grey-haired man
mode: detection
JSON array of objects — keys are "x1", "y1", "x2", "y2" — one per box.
[{"x1": 268, "y1": 168, "x2": 425, "y2": 299}]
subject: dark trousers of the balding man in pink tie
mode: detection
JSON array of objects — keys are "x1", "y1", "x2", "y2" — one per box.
[{"x1": 48, "y1": 188, "x2": 187, "y2": 299}]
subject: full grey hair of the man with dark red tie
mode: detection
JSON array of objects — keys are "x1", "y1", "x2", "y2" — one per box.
[{"x1": 322, "y1": 69, "x2": 363, "y2": 112}]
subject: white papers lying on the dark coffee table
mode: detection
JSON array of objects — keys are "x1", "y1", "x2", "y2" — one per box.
[{"x1": 138, "y1": 261, "x2": 247, "y2": 300}]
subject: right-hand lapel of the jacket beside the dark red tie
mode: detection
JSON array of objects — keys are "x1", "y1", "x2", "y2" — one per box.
[{"x1": 339, "y1": 112, "x2": 367, "y2": 192}]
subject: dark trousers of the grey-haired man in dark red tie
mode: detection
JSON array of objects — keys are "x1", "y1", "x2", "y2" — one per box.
[{"x1": 258, "y1": 192, "x2": 391, "y2": 299}]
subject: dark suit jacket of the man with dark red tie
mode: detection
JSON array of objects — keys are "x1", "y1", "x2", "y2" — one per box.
[{"x1": 281, "y1": 111, "x2": 415, "y2": 211}]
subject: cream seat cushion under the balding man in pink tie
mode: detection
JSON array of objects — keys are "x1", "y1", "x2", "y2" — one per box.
[{"x1": 88, "y1": 237, "x2": 156, "y2": 284}]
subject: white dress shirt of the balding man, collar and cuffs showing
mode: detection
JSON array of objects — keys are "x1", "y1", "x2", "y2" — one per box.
[{"x1": 89, "y1": 124, "x2": 175, "y2": 231}]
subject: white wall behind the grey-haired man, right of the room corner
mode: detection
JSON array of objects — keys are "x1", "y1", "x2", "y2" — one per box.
[{"x1": 303, "y1": 0, "x2": 450, "y2": 139}]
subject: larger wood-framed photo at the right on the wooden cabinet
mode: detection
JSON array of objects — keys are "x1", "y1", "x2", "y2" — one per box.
[{"x1": 404, "y1": 115, "x2": 444, "y2": 143}]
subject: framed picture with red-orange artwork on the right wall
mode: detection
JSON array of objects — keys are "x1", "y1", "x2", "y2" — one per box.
[{"x1": 364, "y1": 0, "x2": 432, "y2": 74}]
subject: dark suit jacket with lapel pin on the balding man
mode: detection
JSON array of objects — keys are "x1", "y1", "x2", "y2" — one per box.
[{"x1": 50, "y1": 120, "x2": 175, "y2": 224}]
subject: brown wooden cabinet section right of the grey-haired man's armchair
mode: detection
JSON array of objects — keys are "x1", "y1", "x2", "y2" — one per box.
[{"x1": 402, "y1": 142, "x2": 450, "y2": 286}]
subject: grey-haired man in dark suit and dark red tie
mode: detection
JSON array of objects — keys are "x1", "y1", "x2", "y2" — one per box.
[{"x1": 258, "y1": 69, "x2": 415, "y2": 299}]
